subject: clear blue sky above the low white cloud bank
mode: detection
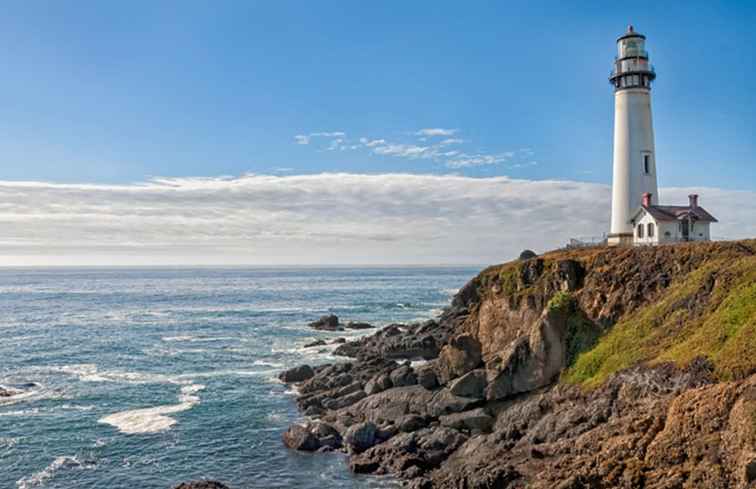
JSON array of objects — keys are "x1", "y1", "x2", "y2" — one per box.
[{"x1": 0, "y1": 1, "x2": 756, "y2": 190}]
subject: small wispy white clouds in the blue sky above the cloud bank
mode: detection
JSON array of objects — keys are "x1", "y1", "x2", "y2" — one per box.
[{"x1": 294, "y1": 128, "x2": 537, "y2": 169}]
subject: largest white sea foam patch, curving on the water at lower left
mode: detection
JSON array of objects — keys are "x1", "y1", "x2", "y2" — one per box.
[{"x1": 99, "y1": 384, "x2": 205, "y2": 435}]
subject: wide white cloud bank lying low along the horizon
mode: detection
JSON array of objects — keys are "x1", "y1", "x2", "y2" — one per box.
[{"x1": 0, "y1": 173, "x2": 756, "y2": 266}]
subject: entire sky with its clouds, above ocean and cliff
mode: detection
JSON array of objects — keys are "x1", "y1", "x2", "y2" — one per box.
[{"x1": 0, "y1": 0, "x2": 756, "y2": 266}]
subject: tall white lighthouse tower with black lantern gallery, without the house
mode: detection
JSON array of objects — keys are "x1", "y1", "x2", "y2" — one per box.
[{"x1": 607, "y1": 26, "x2": 658, "y2": 245}]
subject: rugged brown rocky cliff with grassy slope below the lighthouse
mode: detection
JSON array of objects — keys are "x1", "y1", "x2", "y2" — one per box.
[{"x1": 284, "y1": 241, "x2": 756, "y2": 489}]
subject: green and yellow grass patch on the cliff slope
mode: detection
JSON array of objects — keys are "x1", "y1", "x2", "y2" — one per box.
[{"x1": 562, "y1": 256, "x2": 756, "y2": 388}]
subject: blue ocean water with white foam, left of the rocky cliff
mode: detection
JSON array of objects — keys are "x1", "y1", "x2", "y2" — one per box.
[{"x1": 0, "y1": 268, "x2": 477, "y2": 489}]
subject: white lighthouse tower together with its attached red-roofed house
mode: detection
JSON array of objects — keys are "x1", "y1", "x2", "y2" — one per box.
[{"x1": 607, "y1": 26, "x2": 717, "y2": 246}]
